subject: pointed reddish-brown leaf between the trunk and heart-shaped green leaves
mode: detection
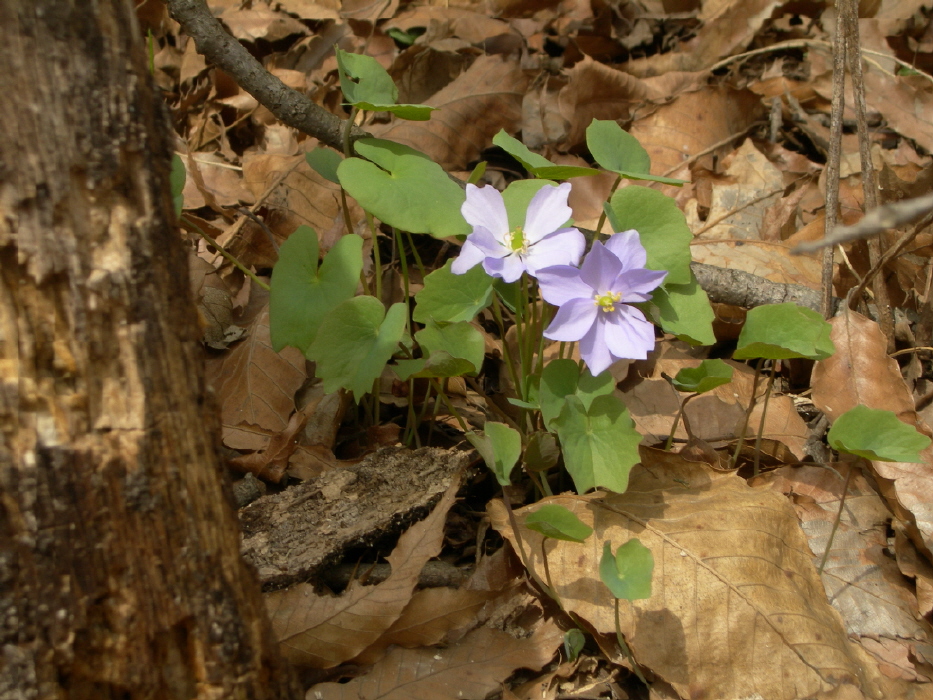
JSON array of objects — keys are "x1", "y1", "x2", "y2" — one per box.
[{"x1": 207, "y1": 305, "x2": 307, "y2": 432}]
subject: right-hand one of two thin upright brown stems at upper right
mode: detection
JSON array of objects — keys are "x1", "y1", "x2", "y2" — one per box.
[{"x1": 840, "y1": 0, "x2": 894, "y2": 352}]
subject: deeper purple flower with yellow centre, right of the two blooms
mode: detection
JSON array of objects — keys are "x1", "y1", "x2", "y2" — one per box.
[{"x1": 537, "y1": 229, "x2": 667, "y2": 376}]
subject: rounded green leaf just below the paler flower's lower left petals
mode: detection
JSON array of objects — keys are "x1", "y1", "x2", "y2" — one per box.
[{"x1": 413, "y1": 260, "x2": 492, "y2": 323}]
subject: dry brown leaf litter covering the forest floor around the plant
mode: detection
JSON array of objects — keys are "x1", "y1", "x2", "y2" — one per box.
[{"x1": 147, "y1": 0, "x2": 933, "y2": 699}]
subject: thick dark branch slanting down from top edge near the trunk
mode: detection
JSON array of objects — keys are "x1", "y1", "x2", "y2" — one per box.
[{"x1": 166, "y1": 0, "x2": 368, "y2": 151}]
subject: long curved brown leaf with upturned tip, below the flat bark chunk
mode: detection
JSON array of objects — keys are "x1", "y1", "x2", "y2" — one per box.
[{"x1": 266, "y1": 470, "x2": 460, "y2": 668}]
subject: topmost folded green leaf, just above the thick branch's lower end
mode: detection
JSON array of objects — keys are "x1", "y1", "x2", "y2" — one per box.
[{"x1": 336, "y1": 49, "x2": 437, "y2": 121}]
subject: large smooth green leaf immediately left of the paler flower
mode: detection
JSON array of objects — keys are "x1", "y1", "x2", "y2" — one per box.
[{"x1": 337, "y1": 139, "x2": 471, "y2": 238}]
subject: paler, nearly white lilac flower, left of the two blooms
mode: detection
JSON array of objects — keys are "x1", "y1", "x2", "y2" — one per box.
[{"x1": 451, "y1": 182, "x2": 586, "y2": 282}]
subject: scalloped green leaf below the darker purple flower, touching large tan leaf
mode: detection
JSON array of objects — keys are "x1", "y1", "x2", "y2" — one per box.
[{"x1": 554, "y1": 394, "x2": 641, "y2": 493}]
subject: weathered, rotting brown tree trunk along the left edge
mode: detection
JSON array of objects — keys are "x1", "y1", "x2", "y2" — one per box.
[{"x1": 0, "y1": 0, "x2": 295, "y2": 698}]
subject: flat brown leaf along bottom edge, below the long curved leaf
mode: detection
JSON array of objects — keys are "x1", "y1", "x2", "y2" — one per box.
[{"x1": 305, "y1": 621, "x2": 563, "y2": 700}]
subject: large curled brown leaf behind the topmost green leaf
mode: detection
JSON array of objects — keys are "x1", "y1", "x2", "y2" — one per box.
[{"x1": 372, "y1": 56, "x2": 528, "y2": 170}]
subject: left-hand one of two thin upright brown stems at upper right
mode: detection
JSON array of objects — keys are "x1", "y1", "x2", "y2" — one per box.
[{"x1": 821, "y1": 0, "x2": 846, "y2": 318}]
